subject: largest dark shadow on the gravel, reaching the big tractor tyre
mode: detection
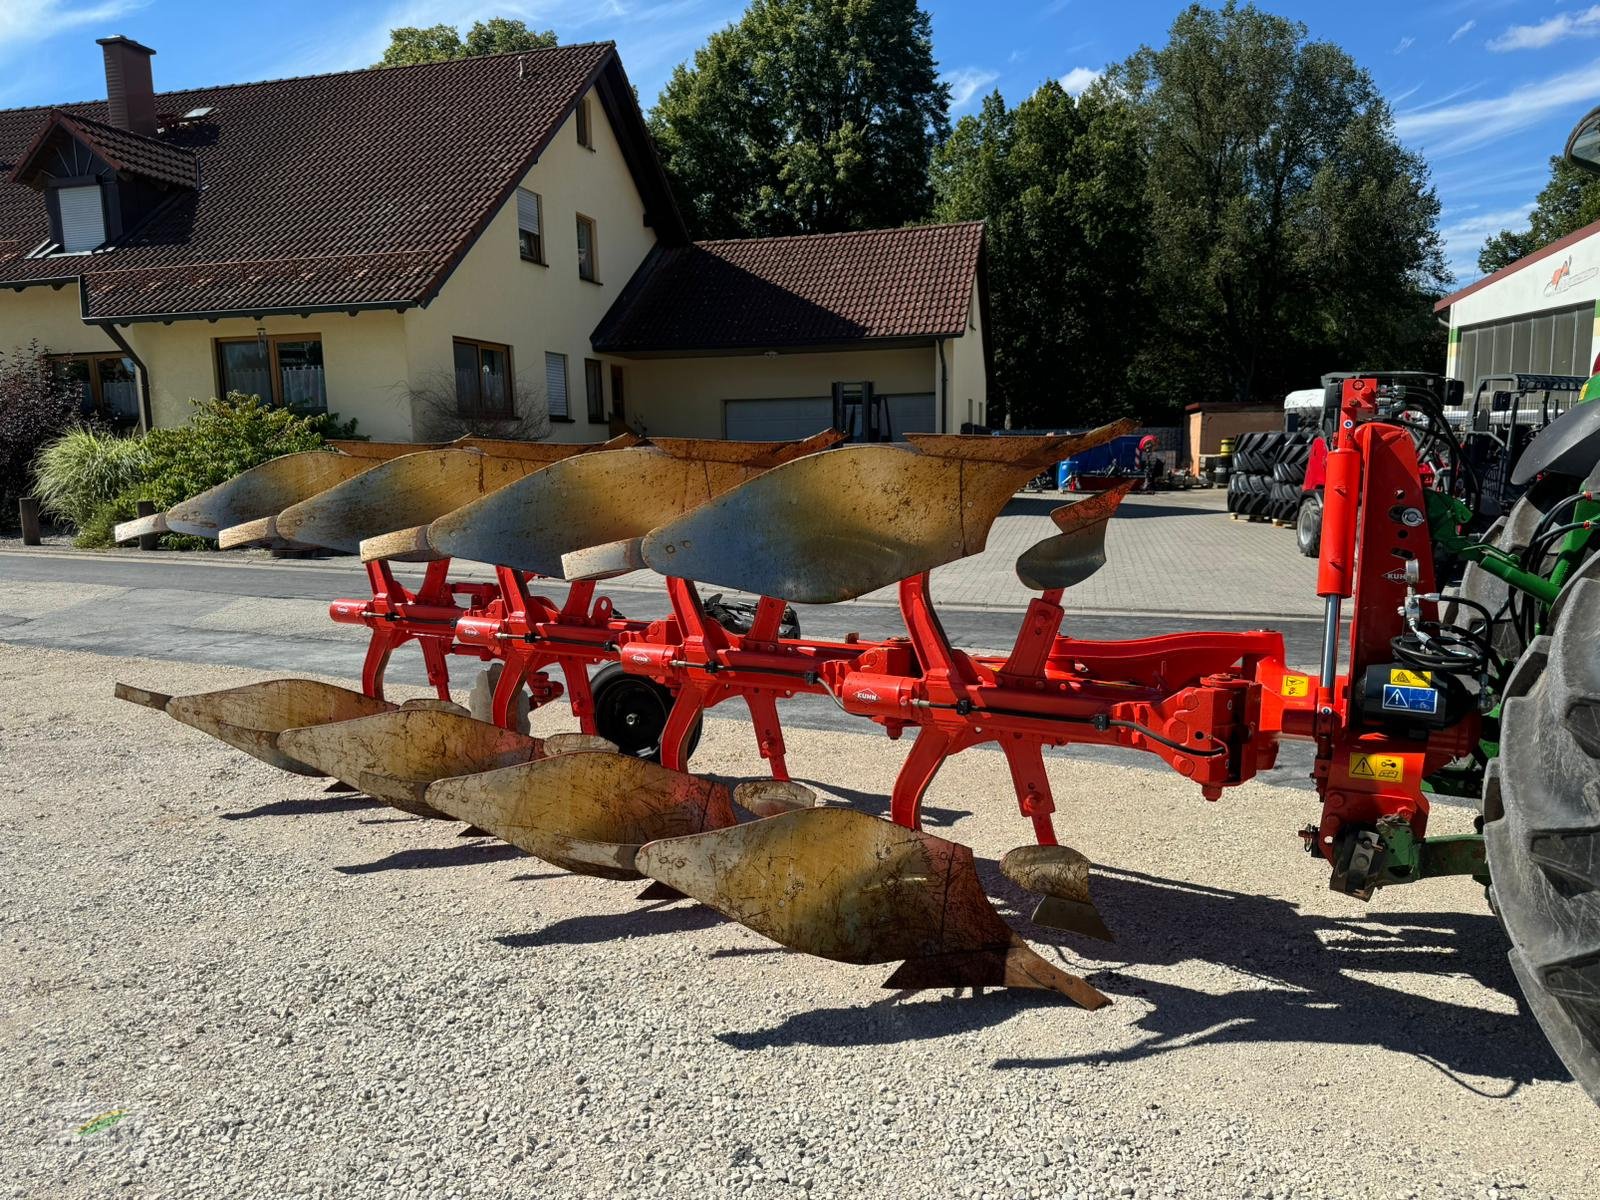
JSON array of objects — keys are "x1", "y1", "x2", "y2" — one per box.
[{"x1": 717, "y1": 859, "x2": 1568, "y2": 1099}]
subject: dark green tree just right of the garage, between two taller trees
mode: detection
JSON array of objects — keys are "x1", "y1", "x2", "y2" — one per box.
[{"x1": 933, "y1": 83, "x2": 1149, "y2": 427}]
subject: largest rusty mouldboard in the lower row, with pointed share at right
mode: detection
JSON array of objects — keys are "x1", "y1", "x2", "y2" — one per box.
[{"x1": 635, "y1": 808, "x2": 1106, "y2": 1008}]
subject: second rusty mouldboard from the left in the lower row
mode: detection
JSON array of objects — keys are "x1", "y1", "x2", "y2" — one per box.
[{"x1": 278, "y1": 709, "x2": 544, "y2": 818}]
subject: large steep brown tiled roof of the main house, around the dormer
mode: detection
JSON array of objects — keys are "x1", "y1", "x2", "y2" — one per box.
[{"x1": 0, "y1": 42, "x2": 683, "y2": 320}]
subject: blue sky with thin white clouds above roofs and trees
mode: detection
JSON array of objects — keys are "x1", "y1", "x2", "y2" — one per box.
[{"x1": 0, "y1": 0, "x2": 1600, "y2": 283}]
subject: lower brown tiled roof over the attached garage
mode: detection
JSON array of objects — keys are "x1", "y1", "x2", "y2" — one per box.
[{"x1": 594, "y1": 221, "x2": 984, "y2": 354}]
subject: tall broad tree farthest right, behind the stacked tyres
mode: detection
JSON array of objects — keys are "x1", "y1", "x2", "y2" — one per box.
[{"x1": 1110, "y1": 0, "x2": 1448, "y2": 412}]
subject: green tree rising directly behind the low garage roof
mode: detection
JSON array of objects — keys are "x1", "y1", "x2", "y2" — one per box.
[{"x1": 651, "y1": 0, "x2": 949, "y2": 237}]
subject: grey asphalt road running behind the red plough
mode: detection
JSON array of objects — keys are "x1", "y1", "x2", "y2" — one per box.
[{"x1": 0, "y1": 549, "x2": 1322, "y2": 787}]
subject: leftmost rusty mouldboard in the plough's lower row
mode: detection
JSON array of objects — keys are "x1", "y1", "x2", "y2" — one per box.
[{"x1": 115, "y1": 678, "x2": 395, "y2": 776}]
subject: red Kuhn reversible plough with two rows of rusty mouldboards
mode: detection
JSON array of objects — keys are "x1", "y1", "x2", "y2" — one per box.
[{"x1": 109, "y1": 376, "x2": 1600, "y2": 1107}]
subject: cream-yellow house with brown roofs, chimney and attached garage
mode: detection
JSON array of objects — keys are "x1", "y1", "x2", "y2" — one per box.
[{"x1": 0, "y1": 37, "x2": 989, "y2": 442}]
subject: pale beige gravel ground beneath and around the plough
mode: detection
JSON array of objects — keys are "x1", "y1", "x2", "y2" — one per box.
[{"x1": 0, "y1": 645, "x2": 1600, "y2": 1200}]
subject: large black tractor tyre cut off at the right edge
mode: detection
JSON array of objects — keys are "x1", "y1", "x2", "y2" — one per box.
[{"x1": 1483, "y1": 579, "x2": 1600, "y2": 1102}]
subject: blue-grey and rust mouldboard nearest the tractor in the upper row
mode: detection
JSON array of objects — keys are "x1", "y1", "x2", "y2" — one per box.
[{"x1": 643, "y1": 438, "x2": 1062, "y2": 603}]
